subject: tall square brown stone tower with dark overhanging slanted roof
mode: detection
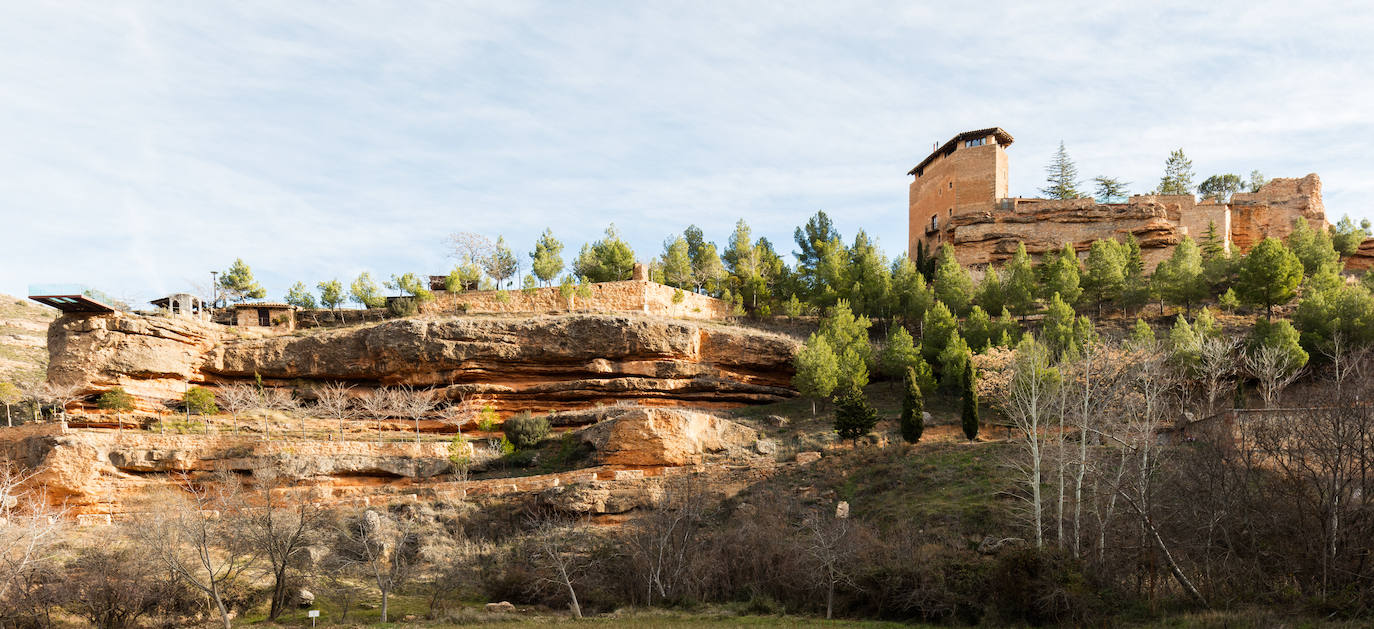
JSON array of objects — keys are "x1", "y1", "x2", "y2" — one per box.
[{"x1": 907, "y1": 126, "x2": 1011, "y2": 260}]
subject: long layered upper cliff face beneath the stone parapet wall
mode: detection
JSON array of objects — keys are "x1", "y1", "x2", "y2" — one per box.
[{"x1": 49, "y1": 315, "x2": 800, "y2": 412}]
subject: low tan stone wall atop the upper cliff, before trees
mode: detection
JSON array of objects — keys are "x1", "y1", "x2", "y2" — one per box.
[{"x1": 420, "y1": 280, "x2": 730, "y2": 320}]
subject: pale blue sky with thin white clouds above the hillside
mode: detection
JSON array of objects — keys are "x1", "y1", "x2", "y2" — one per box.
[{"x1": 0, "y1": 0, "x2": 1374, "y2": 302}]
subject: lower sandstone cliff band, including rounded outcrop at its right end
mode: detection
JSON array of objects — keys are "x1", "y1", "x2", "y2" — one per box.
[{"x1": 0, "y1": 407, "x2": 774, "y2": 522}]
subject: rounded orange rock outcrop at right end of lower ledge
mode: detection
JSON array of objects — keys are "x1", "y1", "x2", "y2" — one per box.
[{"x1": 577, "y1": 408, "x2": 758, "y2": 467}]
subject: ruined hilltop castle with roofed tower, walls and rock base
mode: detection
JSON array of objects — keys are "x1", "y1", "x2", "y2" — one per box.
[{"x1": 907, "y1": 126, "x2": 1327, "y2": 269}]
